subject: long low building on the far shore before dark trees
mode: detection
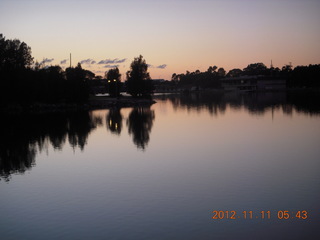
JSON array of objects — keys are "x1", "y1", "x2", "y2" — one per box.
[{"x1": 221, "y1": 76, "x2": 286, "y2": 91}]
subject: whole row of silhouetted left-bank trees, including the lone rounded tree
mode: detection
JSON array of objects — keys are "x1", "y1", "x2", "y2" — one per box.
[{"x1": 0, "y1": 34, "x2": 153, "y2": 106}]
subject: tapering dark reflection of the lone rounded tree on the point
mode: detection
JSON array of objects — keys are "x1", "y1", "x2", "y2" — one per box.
[{"x1": 127, "y1": 107, "x2": 155, "y2": 149}]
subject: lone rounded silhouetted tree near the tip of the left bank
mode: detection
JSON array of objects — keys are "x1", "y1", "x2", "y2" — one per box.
[{"x1": 127, "y1": 55, "x2": 154, "y2": 97}]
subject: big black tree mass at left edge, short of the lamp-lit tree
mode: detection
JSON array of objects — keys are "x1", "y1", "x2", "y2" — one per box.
[{"x1": 0, "y1": 34, "x2": 94, "y2": 105}]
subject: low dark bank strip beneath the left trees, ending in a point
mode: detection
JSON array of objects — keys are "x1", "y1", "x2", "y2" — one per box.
[{"x1": 0, "y1": 96, "x2": 156, "y2": 114}]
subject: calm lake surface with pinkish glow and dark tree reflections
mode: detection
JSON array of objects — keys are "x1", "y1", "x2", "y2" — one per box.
[{"x1": 0, "y1": 93, "x2": 320, "y2": 240}]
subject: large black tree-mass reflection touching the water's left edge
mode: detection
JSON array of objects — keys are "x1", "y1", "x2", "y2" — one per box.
[{"x1": 0, "y1": 112, "x2": 102, "y2": 180}]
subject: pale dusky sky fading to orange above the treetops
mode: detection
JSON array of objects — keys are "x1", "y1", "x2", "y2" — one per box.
[{"x1": 0, "y1": 0, "x2": 320, "y2": 81}]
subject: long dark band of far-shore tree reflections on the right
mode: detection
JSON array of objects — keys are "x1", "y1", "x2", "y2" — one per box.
[{"x1": 157, "y1": 91, "x2": 320, "y2": 115}]
